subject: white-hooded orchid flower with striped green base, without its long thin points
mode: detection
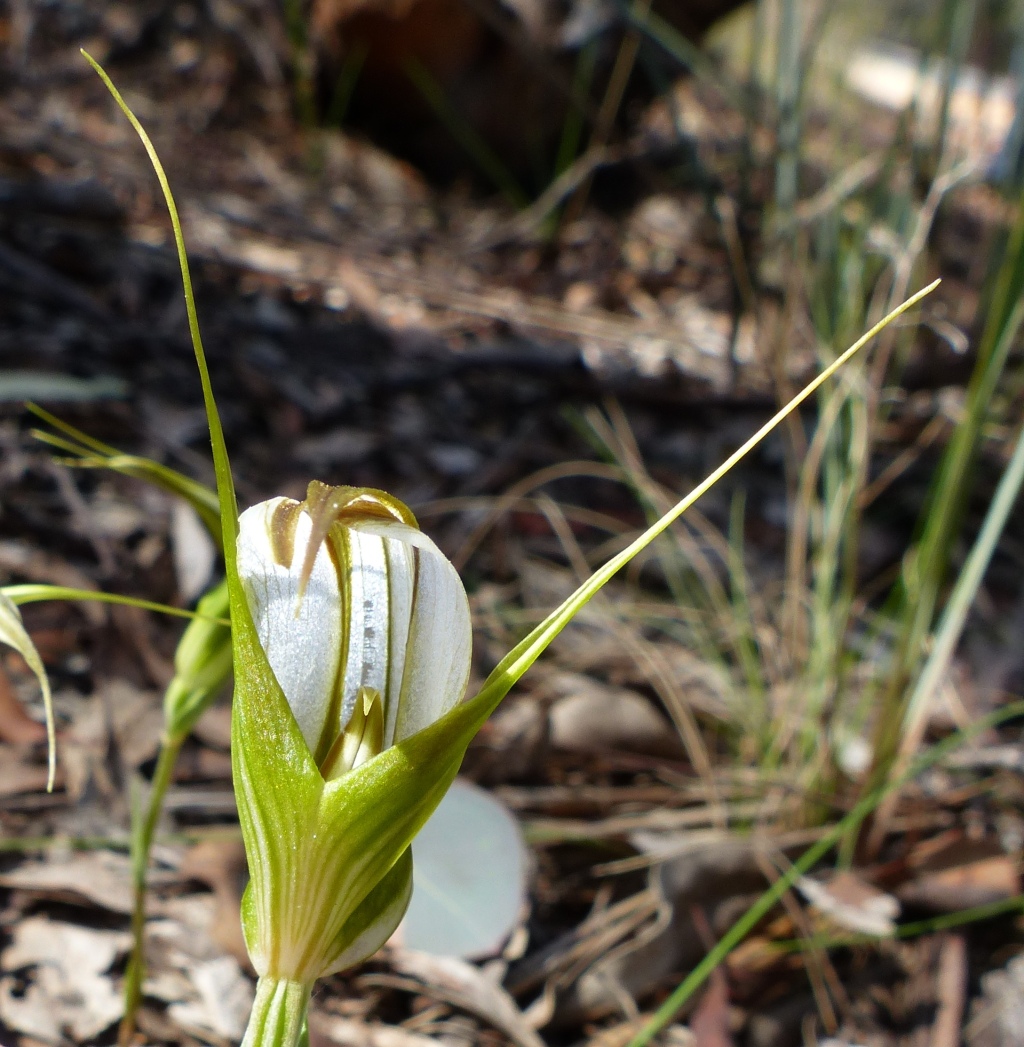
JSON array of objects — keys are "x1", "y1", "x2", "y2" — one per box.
[{"x1": 229, "y1": 483, "x2": 472, "y2": 1044}]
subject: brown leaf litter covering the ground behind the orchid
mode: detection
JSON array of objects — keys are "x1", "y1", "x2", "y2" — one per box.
[{"x1": 0, "y1": 3, "x2": 1024, "y2": 1047}]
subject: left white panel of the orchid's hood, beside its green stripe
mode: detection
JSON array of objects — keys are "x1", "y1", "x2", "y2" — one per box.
[{"x1": 237, "y1": 498, "x2": 341, "y2": 753}]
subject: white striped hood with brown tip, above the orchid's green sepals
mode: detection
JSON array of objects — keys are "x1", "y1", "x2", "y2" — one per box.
[{"x1": 237, "y1": 482, "x2": 472, "y2": 780}]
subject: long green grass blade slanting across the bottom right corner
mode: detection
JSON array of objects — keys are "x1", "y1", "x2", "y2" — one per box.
[{"x1": 628, "y1": 701, "x2": 1024, "y2": 1047}]
